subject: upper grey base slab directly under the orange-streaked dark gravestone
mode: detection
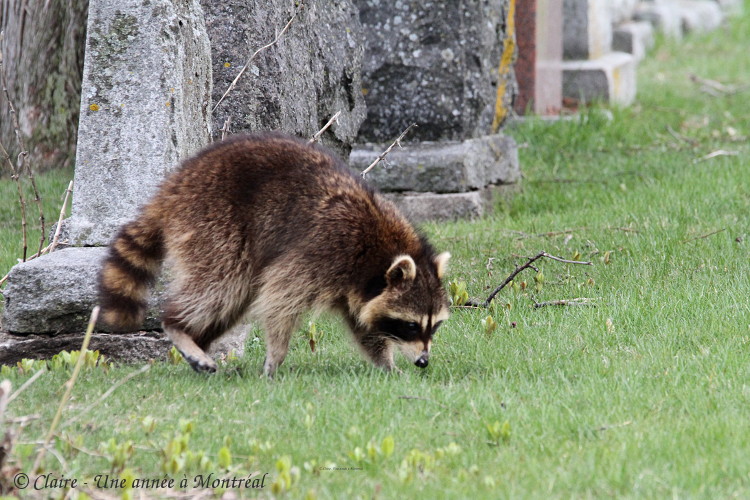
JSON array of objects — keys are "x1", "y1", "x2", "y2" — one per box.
[{"x1": 349, "y1": 135, "x2": 521, "y2": 193}]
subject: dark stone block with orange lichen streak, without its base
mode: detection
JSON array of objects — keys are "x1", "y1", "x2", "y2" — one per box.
[{"x1": 355, "y1": 0, "x2": 516, "y2": 142}]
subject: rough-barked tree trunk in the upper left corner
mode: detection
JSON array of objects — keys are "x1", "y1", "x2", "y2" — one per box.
[{"x1": 0, "y1": 0, "x2": 88, "y2": 170}]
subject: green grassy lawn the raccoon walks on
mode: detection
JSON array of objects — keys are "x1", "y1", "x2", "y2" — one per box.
[{"x1": 0, "y1": 7, "x2": 750, "y2": 498}]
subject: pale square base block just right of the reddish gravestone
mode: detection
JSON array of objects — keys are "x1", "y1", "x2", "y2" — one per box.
[{"x1": 563, "y1": 52, "x2": 636, "y2": 105}]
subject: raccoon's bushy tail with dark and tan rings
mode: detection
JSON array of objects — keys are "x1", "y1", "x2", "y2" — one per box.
[{"x1": 99, "y1": 217, "x2": 164, "y2": 330}]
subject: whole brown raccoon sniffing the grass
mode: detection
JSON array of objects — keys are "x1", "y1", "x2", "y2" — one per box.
[{"x1": 99, "y1": 133, "x2": 449, "y2": 375}]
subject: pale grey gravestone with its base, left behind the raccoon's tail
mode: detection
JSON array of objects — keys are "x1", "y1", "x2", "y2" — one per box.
[{"x1": 0, "y1": 0, "x2": 216, "y2": 363}]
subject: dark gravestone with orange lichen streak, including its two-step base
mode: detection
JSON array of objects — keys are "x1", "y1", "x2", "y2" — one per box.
[{"x1": 350, "y1": 0, "x2": 520, "y2": 222}]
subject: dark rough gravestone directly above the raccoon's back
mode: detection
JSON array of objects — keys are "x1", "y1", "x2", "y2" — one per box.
[{"x1": 201, "y1": 0, "x2": 366, "y2": 155}]
